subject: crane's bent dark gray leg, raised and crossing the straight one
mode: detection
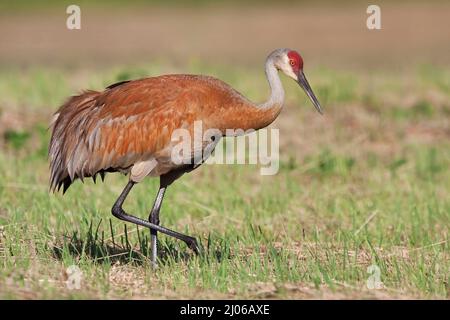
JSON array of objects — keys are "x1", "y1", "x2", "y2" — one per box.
[{"x1": 111, "y1": 181, "x2": 199, "y2": 262}]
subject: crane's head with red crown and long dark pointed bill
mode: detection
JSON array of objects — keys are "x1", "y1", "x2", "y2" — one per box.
[{"x1": 269, "y1": 49, "x2": 322, "y2": 114}]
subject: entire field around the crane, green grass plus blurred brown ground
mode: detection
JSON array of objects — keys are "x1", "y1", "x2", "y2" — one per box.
[{"x1": 0, "y1": 0, "x2": 450, "y2": 299}]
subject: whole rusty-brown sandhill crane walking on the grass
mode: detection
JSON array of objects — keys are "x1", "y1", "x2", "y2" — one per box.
[{"x1": 49, "y1": 48, "x2": 322, "y2": 266}]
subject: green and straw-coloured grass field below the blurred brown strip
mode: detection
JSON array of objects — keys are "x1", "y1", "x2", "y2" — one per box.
[{"x1": 0, "y1": 62, "x2": 450, "y2": 298}]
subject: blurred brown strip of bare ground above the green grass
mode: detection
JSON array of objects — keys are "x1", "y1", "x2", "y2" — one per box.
[{"x1": 0, "y1": 0, "x2": 450, "y2": 69}]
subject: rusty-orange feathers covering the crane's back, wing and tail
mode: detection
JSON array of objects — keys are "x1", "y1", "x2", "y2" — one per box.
[{"x1": 49, "y1": 75, "x2": 281, "y2": 192}]
